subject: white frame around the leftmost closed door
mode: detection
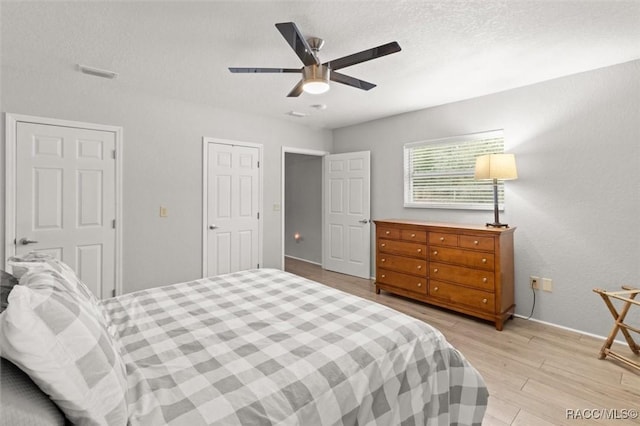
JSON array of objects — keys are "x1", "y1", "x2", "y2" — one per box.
[{"x1": 0, "y1": 112, "x2": 123, "y2": 295}]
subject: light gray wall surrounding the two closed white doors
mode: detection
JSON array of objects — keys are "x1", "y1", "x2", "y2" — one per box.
[{"x1": 0, "y1": 65, "x2": 332, "y2": 292}]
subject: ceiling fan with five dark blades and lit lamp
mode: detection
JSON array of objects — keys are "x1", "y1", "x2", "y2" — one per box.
[{"x1": 229, "y1": 22, "x2": 401, "y2": 97}]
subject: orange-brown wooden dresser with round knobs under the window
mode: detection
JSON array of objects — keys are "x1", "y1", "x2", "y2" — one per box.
[{"x1": 374, "y1": 220, "x2": 515, "y2": 330}]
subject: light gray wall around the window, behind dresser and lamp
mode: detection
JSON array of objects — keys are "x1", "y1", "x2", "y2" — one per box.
[{"x1": 334, "y1": 61, "x2": 640, "y2": 335}]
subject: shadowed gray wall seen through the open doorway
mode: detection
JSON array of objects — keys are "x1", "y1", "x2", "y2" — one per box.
[{"x1": 284, "y1": 153, "x2": 322, "y2": 264}]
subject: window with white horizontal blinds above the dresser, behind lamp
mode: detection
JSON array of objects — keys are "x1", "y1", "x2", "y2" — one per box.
[{"x1": 404, "y1": 130, "x2": 504, "y2": 210}]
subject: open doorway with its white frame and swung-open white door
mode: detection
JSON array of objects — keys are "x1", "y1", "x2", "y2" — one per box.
[{"x1": 274, "y1": 147, "x2": 371, "y2": 278}]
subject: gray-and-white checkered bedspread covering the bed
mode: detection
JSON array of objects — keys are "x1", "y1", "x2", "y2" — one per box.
[{"x1": 104, "y1": 269, "x2": 488, "y2": 426}]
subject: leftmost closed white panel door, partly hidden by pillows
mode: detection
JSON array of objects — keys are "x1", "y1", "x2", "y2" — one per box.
[{"x1": 15, "y1": 122, "x2": 116, "y2": 298}]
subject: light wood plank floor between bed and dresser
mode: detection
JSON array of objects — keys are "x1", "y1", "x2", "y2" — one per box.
[{"x1": 285, "y1": 258, "x2": 640, "y2": 426}]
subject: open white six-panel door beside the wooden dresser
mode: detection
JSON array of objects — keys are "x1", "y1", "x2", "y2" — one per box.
[{"x1": 324, "y1": 151, "x2": 371, "y2": 278}]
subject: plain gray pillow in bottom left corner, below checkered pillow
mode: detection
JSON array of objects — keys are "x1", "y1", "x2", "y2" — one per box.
[{"x1": 0, "y1": 358, "x2": 70, "y2": 426}]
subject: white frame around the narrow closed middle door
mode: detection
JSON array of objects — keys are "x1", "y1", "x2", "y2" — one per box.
[{"x1": 202, "y1": 136, "x2": 264, "y2": 278}]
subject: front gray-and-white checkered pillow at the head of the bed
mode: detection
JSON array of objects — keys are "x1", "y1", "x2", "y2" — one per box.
[{"x1": 0, "y1": 269, "x2": 128, "y2": 425}]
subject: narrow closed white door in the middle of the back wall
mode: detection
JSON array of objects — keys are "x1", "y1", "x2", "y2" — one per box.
[{"x1": 205, "y1": 142, "x2": 260, "y2": 276}]
